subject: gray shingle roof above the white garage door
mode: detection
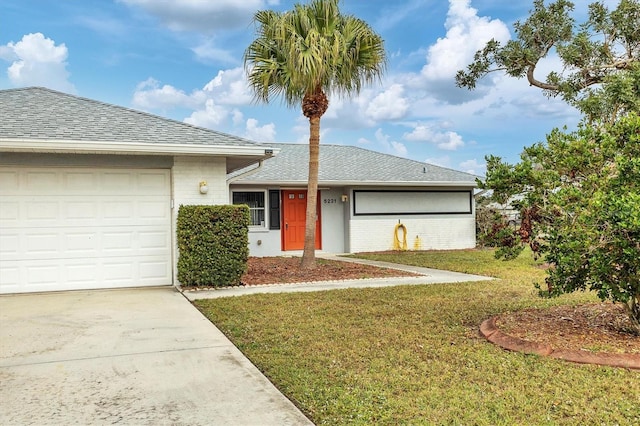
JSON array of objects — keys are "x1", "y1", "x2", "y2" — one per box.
[{"x1": 0, "y1": 87, "x2": 260, "y2": 146}]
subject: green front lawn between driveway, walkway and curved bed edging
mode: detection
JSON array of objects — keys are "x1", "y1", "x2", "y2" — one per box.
[{"x1": 196, "y1": 250, "x2": 640, "y2": 425}]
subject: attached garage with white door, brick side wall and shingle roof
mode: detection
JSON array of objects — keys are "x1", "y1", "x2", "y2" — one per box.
[{"x1": 0, "y1": 87, "x2": 274, "y2": 294}]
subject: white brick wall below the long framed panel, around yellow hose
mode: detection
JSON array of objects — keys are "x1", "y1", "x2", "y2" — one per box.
[{"x1": 349, "y1": 215, "x2": 476, "y2": 253}]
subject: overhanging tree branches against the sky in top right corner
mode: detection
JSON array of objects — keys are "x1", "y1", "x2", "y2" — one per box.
[{"x1": 456, "y1": 0, "x2": 640, "y2": 122}]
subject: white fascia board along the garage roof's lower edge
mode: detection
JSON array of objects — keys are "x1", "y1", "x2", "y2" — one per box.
[{"x1": 0, "y1": 139, "x2": 280, "y2": 157}]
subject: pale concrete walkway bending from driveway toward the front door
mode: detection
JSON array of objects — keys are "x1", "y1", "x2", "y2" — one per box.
[{"x1": 183, "y1": 254, "x2": 495, "y2": 300}]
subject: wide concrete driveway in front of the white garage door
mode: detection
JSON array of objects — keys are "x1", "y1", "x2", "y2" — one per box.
[{"x1": 0, "y1": 288, "x2": 311, "y2": 425}]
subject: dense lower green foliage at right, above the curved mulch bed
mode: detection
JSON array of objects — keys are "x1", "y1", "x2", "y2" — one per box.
[{"x1": 482, "y1": 114, "x2": 640, "y2": 324}]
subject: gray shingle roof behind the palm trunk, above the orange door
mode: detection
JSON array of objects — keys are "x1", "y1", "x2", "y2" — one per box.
[{"x1": 229, "y1": 144, "x2": 476, "y2": 186}]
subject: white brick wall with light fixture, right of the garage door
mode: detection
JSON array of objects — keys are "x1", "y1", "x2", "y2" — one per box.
[{"x1": 171, "y1": 157, "x2": 229, "y2": 283}]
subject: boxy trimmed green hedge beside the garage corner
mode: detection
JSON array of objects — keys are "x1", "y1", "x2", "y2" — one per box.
[{"x1": 177, "y1": 205, "x2": 250, "y2": 287}]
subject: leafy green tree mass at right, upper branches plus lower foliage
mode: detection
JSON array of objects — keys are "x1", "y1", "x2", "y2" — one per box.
[{"x1": 456, "y1": 0, "x2": 640, "y2": 333}]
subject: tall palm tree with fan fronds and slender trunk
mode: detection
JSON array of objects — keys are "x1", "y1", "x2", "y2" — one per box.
[{"x1": 244, "y1": 0, "x2": 386, "y2": 269}]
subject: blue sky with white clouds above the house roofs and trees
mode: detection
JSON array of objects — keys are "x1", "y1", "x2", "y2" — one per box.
[{"x1": 0, "y1": 0, "x2": 617, "y2": 175}]
